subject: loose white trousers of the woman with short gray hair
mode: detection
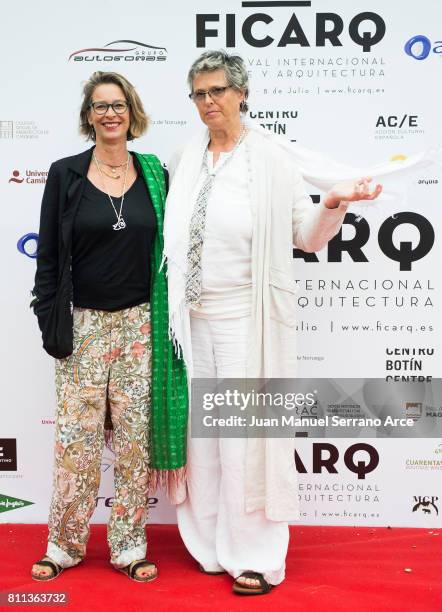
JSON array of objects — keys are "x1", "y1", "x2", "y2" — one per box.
[{"x1": 177, "y1": 317, "x2": 289, "y2": 585}]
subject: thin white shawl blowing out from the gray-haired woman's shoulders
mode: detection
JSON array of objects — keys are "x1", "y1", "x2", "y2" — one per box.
[{"x1": 164, "y1": 119, "x2": 432, "y2": 380}]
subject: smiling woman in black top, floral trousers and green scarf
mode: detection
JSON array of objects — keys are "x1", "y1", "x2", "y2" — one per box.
[{"x1": 32, "y1": 72, "x2": 187, "y2": 582}]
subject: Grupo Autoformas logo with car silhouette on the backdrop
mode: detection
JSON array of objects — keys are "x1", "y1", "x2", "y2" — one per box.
[{"x1": 68, "y1": 40, "x2": 167, "y2": 62}]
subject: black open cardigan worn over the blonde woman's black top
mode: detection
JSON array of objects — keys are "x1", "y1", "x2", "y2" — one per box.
[{"x1": 31, "y1": 147, "x2": 168, "y2": 358}]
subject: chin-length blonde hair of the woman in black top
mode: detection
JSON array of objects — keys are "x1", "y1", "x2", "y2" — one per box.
[{"x1": 80, "y1": 70, "x2": 149, "y2": 141}]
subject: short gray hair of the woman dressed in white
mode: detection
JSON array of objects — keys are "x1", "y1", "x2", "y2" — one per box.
[{"x1": 187, "y1": 49, "x2": 249, "y2": 113}]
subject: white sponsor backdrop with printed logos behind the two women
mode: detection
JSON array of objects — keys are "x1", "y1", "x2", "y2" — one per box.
[{"x1": 0, "y1": 0, "x2": 442, "y2": 528}]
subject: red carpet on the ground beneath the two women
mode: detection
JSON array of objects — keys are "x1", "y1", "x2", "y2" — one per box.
[{"x1": 0, "y1": 525, "x2": 442, "y2": 612}]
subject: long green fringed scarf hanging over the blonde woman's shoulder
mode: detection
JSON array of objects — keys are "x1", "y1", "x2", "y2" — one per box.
[{"x1": 136, "y1": 153, "x2": 188, "y2": 480}]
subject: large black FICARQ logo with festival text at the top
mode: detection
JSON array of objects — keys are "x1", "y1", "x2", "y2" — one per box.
[{"x1": 195, "y1": 2, "x2": 387, "y2": 98}]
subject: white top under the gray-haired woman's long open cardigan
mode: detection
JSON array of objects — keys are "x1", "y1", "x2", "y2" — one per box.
[{"x1": 191, "y1": 141, "x2": 253, "y2": 319}]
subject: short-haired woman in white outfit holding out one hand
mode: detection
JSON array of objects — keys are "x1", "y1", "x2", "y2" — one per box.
[{"x1": 165, "y1": 51, "x2": 381, "y2": 595}]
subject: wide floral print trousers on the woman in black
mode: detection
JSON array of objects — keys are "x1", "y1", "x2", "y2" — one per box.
[{"x1": 47, "y1": 304, "x2": 152, "y2": 567}]
